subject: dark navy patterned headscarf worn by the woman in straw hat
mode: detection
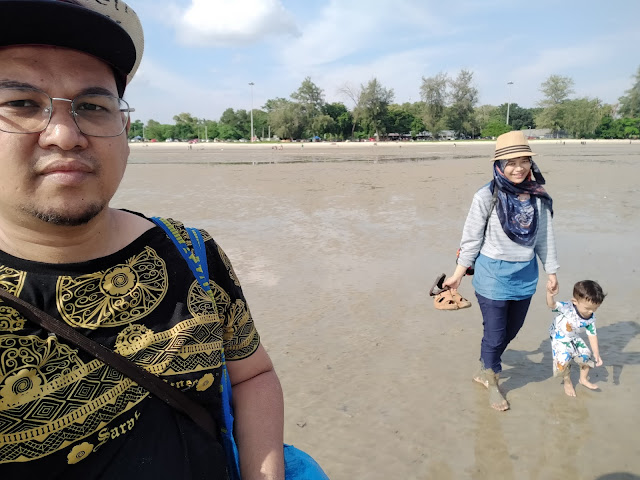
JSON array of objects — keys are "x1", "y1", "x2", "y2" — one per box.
[{"x1": 491, "y1": 159, "x2": 553, "y2": 247}]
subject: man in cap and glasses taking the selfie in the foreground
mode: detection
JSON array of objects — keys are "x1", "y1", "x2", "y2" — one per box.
[{"x1": 0, "y1": 0, "x2": 284, "y2": 480}]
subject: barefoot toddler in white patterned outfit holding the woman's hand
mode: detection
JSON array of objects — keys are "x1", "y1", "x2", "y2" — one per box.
[{"x1": 547, "y1": 280, "x2": 606, "y2": 397}]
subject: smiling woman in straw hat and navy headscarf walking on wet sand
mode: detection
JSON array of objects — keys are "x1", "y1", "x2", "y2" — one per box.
[{"x1": 443, "y1": 131, "x2": 559, "y2": 410}]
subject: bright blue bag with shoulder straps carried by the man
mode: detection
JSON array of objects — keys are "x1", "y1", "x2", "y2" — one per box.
[{"x1": 150, "y1": 217, "x2": 329, "y2": 480}]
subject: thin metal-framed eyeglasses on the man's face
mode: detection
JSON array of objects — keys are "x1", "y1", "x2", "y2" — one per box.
[{"x1": 0, "y1": 87, "x2": 134, "y2": 137}]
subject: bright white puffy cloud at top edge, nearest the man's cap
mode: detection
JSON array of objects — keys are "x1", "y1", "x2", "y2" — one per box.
[{"x1": 173, "y1": 0, "x2": 298, "y2": 47}]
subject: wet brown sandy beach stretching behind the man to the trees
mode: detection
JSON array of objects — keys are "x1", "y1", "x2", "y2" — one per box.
[{"x1": 112, "y1": 141, "x2": 640, "y2": 480}]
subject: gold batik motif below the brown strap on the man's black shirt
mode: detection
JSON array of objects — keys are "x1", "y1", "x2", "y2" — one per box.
[{"x1": 0, "y1": 335, "x2": 148, "y2": 463}]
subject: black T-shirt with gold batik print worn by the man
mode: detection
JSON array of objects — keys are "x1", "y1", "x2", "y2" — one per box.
[{"x1": 0, "y1": 221, "x2": 260, "y2": 480}]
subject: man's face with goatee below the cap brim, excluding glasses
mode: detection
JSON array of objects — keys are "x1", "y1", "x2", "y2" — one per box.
[{"x1": 0, "y1": 46, "x2": 129, "y2": 225}]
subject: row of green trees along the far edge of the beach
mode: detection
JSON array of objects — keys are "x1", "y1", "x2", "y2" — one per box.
[{"x1": 129, "y1": 67, "x2": 640, "y2": 141}]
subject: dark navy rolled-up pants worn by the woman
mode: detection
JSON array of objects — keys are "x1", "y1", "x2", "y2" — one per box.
[{"x1": 476, "y1": 293, "x2": 531, "y2": 373}]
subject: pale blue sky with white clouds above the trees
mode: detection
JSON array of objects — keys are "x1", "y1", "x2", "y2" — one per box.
[{"x1": 125, "y1": 0, "x2": 640, "y2": 123}]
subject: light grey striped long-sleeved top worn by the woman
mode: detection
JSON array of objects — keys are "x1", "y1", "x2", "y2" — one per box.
[{"x1": 458, "y1": 184, "x2": 560, "y2": 273}]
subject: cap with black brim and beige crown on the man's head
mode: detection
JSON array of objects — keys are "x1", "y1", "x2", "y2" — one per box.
[{"x1": 0, "y1": 0, "x2": 144, "y2": 84}]
